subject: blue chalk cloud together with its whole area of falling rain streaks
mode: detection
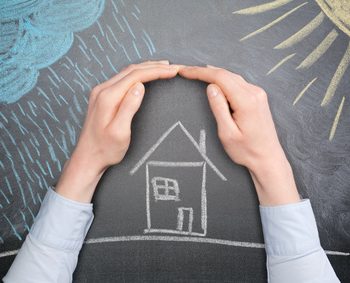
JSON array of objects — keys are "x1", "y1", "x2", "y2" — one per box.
[{"x1": 0, "y1": 0, "x2": 156, "y2": 248}]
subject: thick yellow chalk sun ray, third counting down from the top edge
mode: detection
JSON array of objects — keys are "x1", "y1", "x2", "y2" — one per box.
[{"x1": 274, "y1": 12, "x2": 325, "y2": 49}]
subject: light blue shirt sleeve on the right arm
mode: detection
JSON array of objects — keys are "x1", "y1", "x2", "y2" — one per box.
[{"x1": 260, "y1": 199, "x2": 340, "y2": 283}]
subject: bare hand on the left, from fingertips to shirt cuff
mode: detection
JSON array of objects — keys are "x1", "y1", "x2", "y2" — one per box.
[{"x1": 56, "y1": 61, "x2": 178, "y2": 202}]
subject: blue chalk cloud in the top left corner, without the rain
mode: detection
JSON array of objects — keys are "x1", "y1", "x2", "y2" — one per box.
[{"x1": 0, "y1": 0, "x2": 104, "y2": 103}]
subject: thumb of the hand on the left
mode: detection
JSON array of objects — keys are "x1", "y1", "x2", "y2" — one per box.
[{"x1": 111, "y1": 82, "x2": 145, "y2": 132}]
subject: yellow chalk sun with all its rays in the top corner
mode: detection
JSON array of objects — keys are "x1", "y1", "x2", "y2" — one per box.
[{"x1": 233, "y1": 0, "x2": 350, "y2": 140}]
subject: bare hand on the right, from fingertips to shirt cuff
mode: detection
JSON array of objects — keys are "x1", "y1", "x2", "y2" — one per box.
[{"x1": 179, "y1": 66, "x2": 300, "y2": 205}]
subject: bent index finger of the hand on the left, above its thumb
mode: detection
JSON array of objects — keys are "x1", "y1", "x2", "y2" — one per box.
[{"x1": 105, "y1": 65, "x2": 179, "y2": 105}]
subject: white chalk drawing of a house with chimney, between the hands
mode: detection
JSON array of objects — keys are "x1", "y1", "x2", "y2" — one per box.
[{"x1": 130, "y1": 121, "x2": 226, "y2": 236}]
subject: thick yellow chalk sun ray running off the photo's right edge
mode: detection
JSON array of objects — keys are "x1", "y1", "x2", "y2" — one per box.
[{"x1": 321, "y1": 41, "x2": 350, "y2": 106}]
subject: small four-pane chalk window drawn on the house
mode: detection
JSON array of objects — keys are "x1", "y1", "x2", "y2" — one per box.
[{"x1": 151, "y1": 177, "x2": 180, "y2": 201}]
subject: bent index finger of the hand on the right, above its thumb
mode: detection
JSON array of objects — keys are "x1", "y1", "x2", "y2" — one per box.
[{"x1": 179, "y1": 67, "x2": 247, "y2": 110}]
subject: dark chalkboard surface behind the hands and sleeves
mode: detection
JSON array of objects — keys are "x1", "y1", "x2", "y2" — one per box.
[{"x1": 0, "y1": 0, "x2": 350, "y2": 282}]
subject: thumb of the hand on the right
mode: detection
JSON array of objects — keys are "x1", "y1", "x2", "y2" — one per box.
[{"x1": 207, "y1": 84, "x2": 240, "y2": 135}]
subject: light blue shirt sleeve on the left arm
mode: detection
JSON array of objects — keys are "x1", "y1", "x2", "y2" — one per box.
[{"x1": 3, "y1": 189, "x2": 93, "y2": 283}]
